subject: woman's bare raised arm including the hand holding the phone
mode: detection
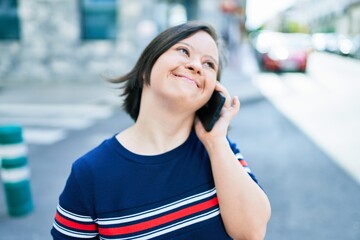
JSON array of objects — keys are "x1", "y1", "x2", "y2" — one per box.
[{"x1": 195, "y1": 84, "x2": 271, "y2": 239}]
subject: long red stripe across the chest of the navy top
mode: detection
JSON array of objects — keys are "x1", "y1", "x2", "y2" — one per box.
[{"x1": 99, "y1": 197, "x2": 218, "y2": 236}]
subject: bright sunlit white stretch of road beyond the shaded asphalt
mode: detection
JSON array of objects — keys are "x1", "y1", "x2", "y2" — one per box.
[{"x1": 253, "y1": 53, "x2": 360, "y2": 184}]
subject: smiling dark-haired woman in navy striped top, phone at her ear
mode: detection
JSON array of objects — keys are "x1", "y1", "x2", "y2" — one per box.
[{"x1": 52, "y1": 22, "x2": 270, "y2": 240}]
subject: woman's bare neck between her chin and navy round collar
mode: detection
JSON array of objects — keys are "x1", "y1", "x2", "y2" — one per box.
[{"x1": 117, "y1": 94, "x2": 194, "y2": 155}]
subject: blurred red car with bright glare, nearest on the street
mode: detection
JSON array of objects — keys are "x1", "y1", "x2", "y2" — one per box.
[{"x1": 253, "y1": 31, "x2": 312, "y2": 72}]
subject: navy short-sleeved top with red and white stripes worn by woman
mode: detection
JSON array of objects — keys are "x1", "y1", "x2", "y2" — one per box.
[{"x1": 51, "y1": 132, "x2": 256, "y2": 240}]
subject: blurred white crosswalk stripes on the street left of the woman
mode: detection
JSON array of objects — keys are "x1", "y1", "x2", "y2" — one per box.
[{"x1": 0, "y1": 103, "x2": 114, "y2": 145}]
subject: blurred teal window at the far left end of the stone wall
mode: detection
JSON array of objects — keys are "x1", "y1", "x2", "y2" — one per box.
[{"x1": 0, "y1": 0, "x2": 20, "y2": 40}]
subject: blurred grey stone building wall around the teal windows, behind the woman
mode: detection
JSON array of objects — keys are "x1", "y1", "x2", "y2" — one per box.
[{"x1": 0, "y1": 0, "x2": 222, "y2": 86}]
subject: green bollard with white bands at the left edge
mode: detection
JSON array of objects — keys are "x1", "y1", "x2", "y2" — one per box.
[{"x1": 0, "y1": 125, "x2": 34, "y2": 216}]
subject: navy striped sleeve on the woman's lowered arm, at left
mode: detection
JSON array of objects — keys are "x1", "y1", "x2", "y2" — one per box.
[{"x1": 51, "y1": 158, "x2": 98, "y2": 239}]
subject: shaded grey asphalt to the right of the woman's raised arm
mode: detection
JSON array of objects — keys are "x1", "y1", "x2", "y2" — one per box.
[{"x1": 230, "y1": 96, "x2": 360, "y2": 240}]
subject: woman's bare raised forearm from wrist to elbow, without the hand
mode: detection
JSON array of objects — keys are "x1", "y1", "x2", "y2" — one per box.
[{"x1": 206, "y1": 139, "x2": 271, "y2": 239}]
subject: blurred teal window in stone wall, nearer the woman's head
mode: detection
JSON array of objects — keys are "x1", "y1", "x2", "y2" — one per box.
[{"x1": 81, "y1": 0, "x2": 117, "y2": 40}]
